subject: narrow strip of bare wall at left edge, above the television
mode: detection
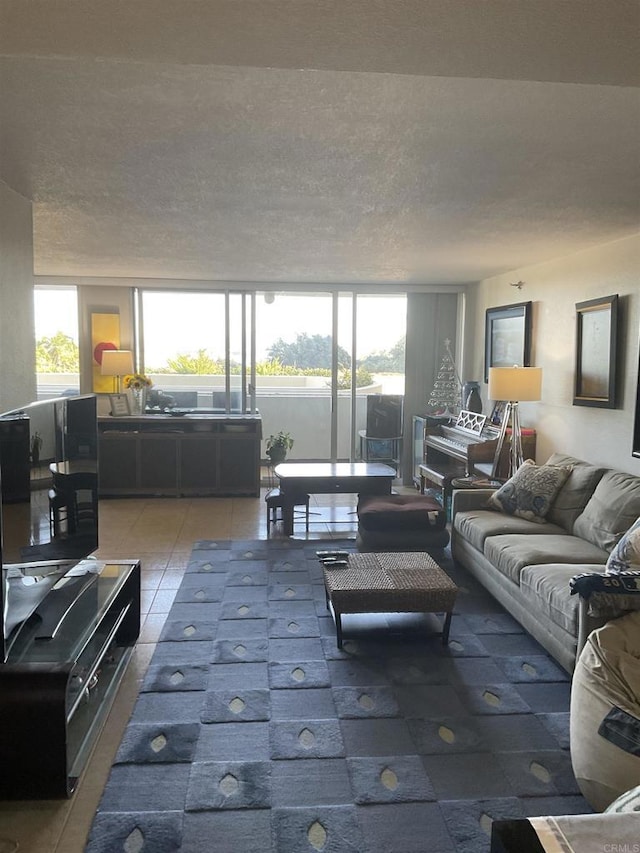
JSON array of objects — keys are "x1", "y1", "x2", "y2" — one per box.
[{"x1": 0, "y1": 181, "x2": 36, "y2": 411}]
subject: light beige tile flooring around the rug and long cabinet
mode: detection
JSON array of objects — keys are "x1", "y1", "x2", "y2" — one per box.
[{"x1": 0, "y1": 488, "x2": 411, "y2": 853}]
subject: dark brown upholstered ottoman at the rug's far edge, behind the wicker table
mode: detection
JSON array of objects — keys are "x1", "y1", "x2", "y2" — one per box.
[{"x1": 357, "y1": 495, "x2": 449, "y2": 553}]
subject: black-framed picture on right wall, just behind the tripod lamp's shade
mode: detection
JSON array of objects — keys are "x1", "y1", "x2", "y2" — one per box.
[{"x1": 484, "y1": 302, "x2": 531, "y2": 382}]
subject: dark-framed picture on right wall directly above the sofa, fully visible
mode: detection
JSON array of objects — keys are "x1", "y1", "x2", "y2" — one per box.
[{"x1": 573, "y1": 294, "x2": 618, "y2": 409}]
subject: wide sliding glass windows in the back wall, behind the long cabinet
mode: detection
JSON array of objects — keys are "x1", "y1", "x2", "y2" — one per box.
[{"x1": 138, "y1": 290, "x2": 406, "y2": 459}]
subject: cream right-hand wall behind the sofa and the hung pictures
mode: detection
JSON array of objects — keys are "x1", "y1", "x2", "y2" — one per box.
[{"x1": 471, "y1": 235, "x2": 640, "y2": 474}]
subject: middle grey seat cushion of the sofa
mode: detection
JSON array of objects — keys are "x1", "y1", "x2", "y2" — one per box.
[{"x1": 484, "y1": 533, "x2": 608, "y2": 584}]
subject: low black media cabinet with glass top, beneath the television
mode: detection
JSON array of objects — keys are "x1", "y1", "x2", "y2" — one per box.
[{"x1": 0, "y1": 560, "x2": 140, "y2": 800}]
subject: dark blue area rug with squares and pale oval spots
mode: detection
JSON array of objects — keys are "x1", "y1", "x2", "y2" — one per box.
[{"x1": 86, "y1": 540, "x2": 591, "y2": 853}]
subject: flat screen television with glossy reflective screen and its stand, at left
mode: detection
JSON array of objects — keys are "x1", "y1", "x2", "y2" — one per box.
[{"x1": 0, "y1": 395, "x2": 98, "y2": 662}]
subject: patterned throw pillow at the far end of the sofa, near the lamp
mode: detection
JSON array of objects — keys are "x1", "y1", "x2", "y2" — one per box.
[{"x1": 489, "y1": 459, "x2": 571, "y2": 524}]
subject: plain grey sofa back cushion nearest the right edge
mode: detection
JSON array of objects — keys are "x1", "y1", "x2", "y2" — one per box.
[{"x1": 573, "y1": 471, "x2": 640, "y2": 553}]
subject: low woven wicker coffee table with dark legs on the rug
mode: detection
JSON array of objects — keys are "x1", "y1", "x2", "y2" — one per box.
[{"x1": 323, "y1": 551, "x2": 458, "y2": 649}]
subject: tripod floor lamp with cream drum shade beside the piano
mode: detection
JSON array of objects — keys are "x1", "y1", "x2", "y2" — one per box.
[{"x1": 489, "y1": 367, "x2": 542, "y2": 479}]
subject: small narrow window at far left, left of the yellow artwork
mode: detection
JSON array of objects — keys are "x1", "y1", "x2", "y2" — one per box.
[{"x1": 34, "y1": 285, "x2": 80, "y2": 400}]
